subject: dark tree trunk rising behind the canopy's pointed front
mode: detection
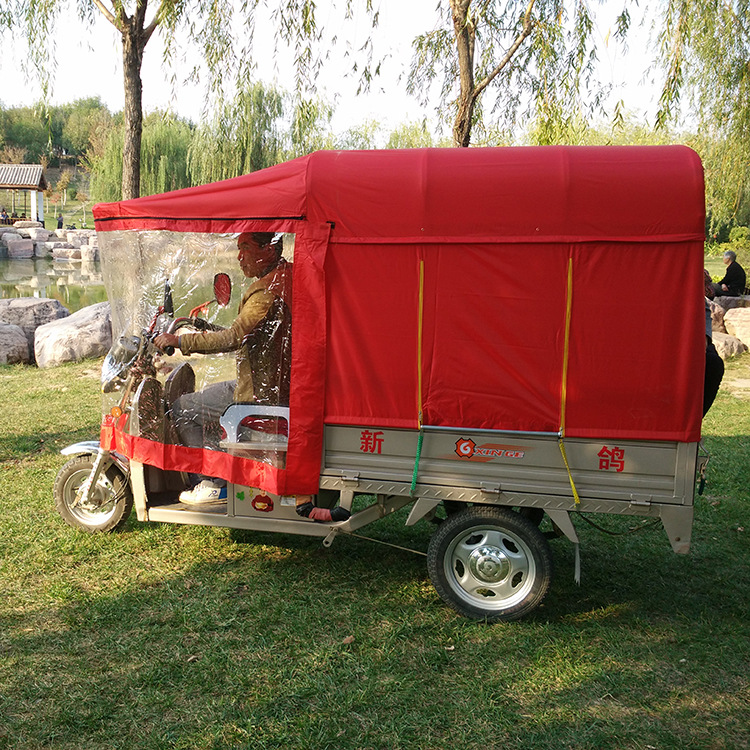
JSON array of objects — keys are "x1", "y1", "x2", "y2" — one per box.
[{"x1": 122, "y1": 12, "x2": 147, "y2": 200}]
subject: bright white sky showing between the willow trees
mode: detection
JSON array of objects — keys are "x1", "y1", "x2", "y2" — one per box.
[{"x1": 0, "y1": 0, "x2": 656, "y2": 138}]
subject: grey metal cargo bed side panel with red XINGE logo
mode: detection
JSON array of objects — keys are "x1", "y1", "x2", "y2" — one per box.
[{"x1": 321, "y1": 426, "x2": 697, "y2": 515}]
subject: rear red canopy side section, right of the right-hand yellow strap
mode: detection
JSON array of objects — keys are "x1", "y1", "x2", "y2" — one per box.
[{"x1": 565, "y1": 243, "x2": 705, "y2": 441}]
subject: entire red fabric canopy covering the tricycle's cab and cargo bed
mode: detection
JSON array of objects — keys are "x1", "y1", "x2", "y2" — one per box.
[{"x1": 94, "y1": 146, "x2": 705, "y2": 493}]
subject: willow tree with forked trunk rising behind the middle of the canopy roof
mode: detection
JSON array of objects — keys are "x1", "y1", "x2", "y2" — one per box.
[{"x1": 408, "y1": 0, "x2": 628, "y2": 146}]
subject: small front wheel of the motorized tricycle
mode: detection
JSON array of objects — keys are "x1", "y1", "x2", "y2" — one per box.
[{"x1": 52, "y1": 455, "x2": 133, "y2": 534}]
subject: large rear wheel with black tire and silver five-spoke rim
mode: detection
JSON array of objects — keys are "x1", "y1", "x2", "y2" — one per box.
[{"x1": 427, "y1": 506, "x2": 552, "y2": 622}]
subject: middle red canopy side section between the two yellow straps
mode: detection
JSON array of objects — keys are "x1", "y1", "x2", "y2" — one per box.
[{"x1": 423, "y1": 244, "x2": 567, "y2": 432}]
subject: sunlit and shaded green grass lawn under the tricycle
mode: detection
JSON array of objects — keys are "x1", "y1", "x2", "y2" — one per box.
[{"x1": 0, "y1": 355, "x2": 750, "y2": 750}]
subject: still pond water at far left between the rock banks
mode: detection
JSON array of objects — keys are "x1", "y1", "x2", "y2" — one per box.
[{"x1": 0, "y1": 258, "x2": 107, "y2": 313}]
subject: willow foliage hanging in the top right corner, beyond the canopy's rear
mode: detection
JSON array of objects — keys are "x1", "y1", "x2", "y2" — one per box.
[{"x1": 655, "y1": 0, "x2": 750, "y2": 228}]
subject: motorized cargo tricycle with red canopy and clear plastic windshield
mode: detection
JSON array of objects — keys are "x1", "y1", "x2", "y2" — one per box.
[{"x1": 54, "y1": 147, "x2": 705, "y2": 621}]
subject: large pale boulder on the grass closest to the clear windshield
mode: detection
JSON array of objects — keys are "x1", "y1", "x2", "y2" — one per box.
[{"x1": 34, "y1": 302, "x2": 112, "y2": 368}]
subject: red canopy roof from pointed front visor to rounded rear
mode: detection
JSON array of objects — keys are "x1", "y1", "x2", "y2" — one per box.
[{"x1": 94, "y1": 146, "x2": 704, "y2": 242}]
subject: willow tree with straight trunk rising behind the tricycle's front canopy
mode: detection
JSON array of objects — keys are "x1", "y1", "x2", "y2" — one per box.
[{"x1": 11, "y1": 0, "x2": 377, "y2": 198}]
